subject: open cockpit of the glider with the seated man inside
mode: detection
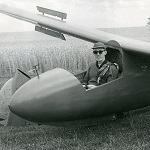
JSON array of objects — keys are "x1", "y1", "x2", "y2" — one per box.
[{"x1": 76, "y1": 41, "x2": 123, "y2": 89}]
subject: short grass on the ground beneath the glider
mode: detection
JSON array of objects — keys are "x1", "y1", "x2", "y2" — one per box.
[{"x1": 0, "y1": 108, "x2": 150, "y2": 150}]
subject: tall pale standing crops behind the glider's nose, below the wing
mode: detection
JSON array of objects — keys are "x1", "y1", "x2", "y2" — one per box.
[{"x1": 0, "y1": 32, "x2": 94, "y2": 77}]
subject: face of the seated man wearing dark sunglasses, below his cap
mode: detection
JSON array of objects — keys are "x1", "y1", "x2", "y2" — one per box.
[{"x1": 93, "y1": 48, "x2": 107, "y2": 62}]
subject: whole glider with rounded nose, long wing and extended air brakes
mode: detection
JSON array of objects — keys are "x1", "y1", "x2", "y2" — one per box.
[{"x1": 0, "y1": 5, "x2": 150, "y2": 125}]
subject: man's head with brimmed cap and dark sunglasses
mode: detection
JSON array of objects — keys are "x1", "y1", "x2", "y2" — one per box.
[{"x1": 92, "y1": 42, "x2": 107, "y2": 62}]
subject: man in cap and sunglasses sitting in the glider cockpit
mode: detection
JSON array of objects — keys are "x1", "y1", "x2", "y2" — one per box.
[{"x1": 82, "y1": 42, "x2": 119, "y2": 89}]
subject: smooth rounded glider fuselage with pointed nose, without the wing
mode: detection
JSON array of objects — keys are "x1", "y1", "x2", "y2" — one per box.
[{"x1": 10, "y1": 50, "x2": 150, "y2": 124}]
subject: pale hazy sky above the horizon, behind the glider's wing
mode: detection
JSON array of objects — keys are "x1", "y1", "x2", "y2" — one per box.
[{"x1": 0, "y1": 0, "x2": 150, "y2": 32}]
